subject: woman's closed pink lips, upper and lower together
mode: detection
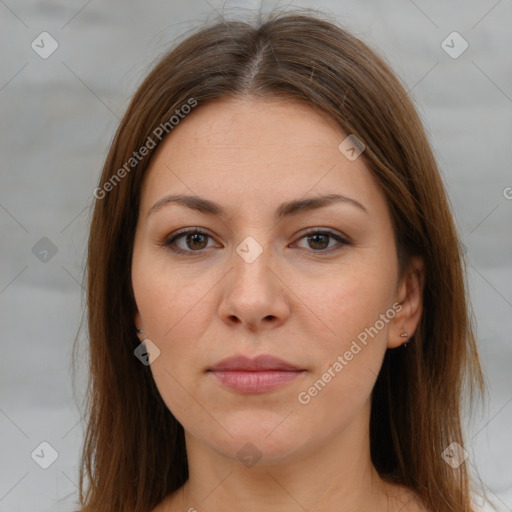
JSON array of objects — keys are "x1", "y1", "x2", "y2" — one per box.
[{"x1": 207, "y1": 355, "x2": 306, "y2": 394}]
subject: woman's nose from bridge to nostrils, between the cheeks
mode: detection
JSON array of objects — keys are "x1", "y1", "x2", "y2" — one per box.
[{"x1": 219, "y1": 240, "x2": 290, "y2": 331}]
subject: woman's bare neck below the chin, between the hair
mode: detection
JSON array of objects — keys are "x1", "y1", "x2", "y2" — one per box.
[{"x1": 173, "y1": 407, "x2": 394, "y2": 512}]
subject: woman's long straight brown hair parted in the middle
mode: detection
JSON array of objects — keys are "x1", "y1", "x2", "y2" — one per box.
[{"x1": 76, "y1": 12, "x2": 484, "y2": 512}]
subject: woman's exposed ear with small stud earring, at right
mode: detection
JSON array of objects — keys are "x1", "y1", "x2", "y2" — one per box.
[{"x1": 387, "y1": 256, "x2": 425, "y2": 348}]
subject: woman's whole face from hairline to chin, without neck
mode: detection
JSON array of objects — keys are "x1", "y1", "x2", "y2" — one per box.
[{"x1": 132, "y1": 99, "x2": 416, "y2": 463}]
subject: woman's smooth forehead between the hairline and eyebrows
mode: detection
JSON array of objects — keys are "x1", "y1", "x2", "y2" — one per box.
[{"x1": 138, "y1": 97, "x2": 382, "y2": 218}]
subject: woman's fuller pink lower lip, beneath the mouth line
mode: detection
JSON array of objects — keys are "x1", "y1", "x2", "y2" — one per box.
[{"x1": 210, "y1": 370, "x2": 304, "y2": 393}]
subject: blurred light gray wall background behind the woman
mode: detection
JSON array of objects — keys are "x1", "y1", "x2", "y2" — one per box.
[{"x1": 0, "y1": 0, "x2": 512, "y2": 512}]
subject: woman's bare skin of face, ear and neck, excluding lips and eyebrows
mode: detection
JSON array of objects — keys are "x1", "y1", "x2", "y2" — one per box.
[{"x1": 132, "y1": 97, "x2": 425, "y2": 512}]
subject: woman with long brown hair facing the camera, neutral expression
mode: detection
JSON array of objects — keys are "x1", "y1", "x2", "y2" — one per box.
[{"x1": 80, "y1": 9, "x2": 483, "y2": 512}]
